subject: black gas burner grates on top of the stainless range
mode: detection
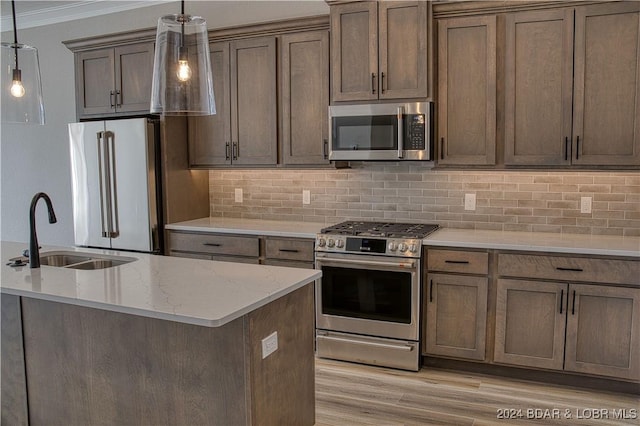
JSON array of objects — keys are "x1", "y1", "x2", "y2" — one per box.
[{"x1": 320, "y1": 220, "x2": 439, "y2": 238}]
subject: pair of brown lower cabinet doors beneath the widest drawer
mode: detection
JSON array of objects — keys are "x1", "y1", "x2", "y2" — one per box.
[{"x1": 494, "y1": 279, "x2": 640, "y2": 380}]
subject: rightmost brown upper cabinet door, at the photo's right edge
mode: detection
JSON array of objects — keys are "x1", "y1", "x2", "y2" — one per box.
[{"x1": 573, "y1": 2, "x2": 640, "y2": 165}]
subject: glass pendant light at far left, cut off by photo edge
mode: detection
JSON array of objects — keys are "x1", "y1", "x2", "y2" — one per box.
[{"x1": 1, "y1": 0, "x2": 44, "y2": 124}]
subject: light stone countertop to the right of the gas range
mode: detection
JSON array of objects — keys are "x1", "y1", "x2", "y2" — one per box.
[{"x1": 422, "y1": 228, "x2": 640, "y2": 258}]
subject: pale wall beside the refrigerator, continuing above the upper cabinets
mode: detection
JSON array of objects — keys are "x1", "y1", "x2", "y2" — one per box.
[{"x1": 0, "y1": 0, "x2": 329, "y2": 245}]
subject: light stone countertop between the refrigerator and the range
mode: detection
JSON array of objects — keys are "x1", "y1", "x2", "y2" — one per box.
[{"x1": 165, "y1": 217, "x2": 329, "y2": 239}]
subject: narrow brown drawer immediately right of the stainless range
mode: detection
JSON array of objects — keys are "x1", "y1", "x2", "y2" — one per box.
[{"x1": 427, "y1": 249, "x2": 489, "y2": 275}]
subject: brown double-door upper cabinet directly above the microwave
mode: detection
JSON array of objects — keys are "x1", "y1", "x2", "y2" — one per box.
[{"x1": 330, "y1": 1, "x2": 431, "y2": 102}]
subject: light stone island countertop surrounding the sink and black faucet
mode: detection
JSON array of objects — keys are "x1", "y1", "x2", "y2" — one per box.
[{"x1": 0, "y1": 241, "x2": 321, "y2": 327}]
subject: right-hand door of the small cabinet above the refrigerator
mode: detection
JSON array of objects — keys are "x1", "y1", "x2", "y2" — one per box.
[{"x1": 115, "y1": 43, "x2": 154, "y2": 112}]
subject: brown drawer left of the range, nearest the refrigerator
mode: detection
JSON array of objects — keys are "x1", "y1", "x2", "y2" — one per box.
[{"x1": 169, "y1": 232, "x2": 260, "y2": 257}]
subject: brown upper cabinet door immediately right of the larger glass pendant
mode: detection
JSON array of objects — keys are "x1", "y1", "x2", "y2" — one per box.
[{"x1": 230, "y1": 37, "x2": 278, "y2": 165}]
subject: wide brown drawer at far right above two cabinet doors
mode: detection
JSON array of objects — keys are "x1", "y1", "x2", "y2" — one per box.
[{"x1": 498, "y1": 253, "x2": 640, "y2": 285}]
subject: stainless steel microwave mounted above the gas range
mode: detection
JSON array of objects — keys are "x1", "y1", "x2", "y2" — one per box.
[{"x1": 329, "y1": 102, "x2": 432, "y2": 161}]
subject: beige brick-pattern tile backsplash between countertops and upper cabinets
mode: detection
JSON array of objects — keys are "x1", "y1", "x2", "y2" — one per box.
[{"x1": 209, "y1": 162, "x2": 640, "y2": 236}]
